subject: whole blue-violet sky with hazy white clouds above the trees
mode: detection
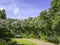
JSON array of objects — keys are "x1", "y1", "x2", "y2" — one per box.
[{"x1": 0, "y1": 0, "x2": 51, "y2": 19}]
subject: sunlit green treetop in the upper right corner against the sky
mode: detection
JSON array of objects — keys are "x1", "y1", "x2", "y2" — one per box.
[{"x1": 50, "y1": 0, "x2": 60, "y2": 13}]
